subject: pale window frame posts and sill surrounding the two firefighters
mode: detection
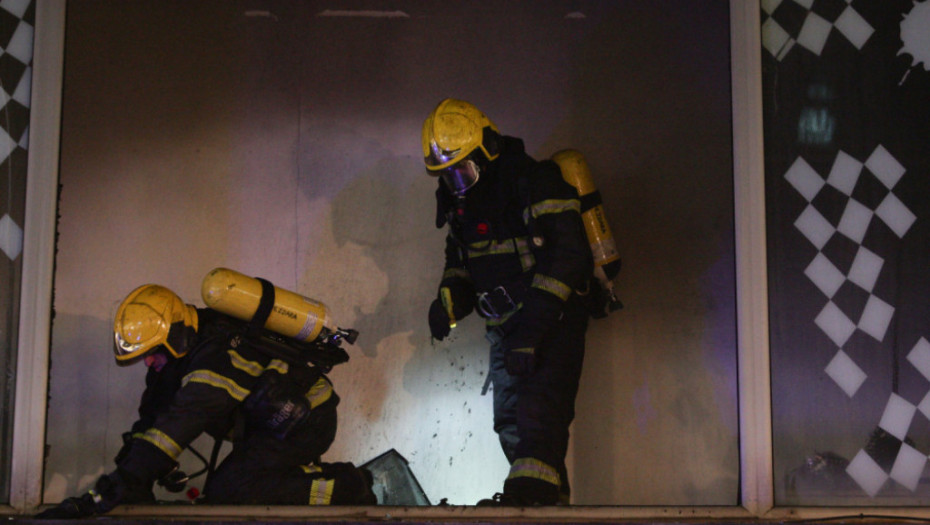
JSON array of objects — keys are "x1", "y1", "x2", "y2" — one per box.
[{"x1": 10, "y1": 0, "x2": 930, "y2": 521}]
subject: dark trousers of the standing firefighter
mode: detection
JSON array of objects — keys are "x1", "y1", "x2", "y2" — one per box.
[{"x1": 488, "y1": 298, "x2": 588, "y2": 495}]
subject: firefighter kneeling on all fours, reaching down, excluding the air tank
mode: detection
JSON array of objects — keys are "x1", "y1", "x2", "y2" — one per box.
[{"x1": 38, "y1": 285, "x2": 376, "y2": 519}]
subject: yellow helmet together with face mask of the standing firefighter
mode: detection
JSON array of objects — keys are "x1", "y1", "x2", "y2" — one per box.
[{"x1": 423, "y1": 98, "x2": 500, "y2": 195}]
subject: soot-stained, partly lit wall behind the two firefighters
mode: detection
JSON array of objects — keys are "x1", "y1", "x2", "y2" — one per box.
[{"x1": 45, "y1": 0, "x2": 739, "y2": 505}]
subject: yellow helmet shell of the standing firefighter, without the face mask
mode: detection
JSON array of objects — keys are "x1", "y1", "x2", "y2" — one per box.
[{"x1": 422, "y1": 98, "x2": 500, "y2": 171}]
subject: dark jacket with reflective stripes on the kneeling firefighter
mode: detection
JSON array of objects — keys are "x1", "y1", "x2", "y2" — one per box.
[{"x1": 117, "y1": 308, "x2": 339, "y2": 486}]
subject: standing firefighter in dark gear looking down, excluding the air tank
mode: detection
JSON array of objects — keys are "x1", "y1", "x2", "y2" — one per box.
[{"x1": 423, "y1": 99, "x2": 593, "y2": 506}]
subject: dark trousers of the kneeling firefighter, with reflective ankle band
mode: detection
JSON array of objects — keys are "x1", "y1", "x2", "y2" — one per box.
[{"x1": 204, "y1": 405, "x2": 376, "y2": 505}]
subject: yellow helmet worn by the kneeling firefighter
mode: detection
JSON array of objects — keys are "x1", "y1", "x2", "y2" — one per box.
[{"x1": 113, "y1": 284, "x2": 197, "y2": 362}]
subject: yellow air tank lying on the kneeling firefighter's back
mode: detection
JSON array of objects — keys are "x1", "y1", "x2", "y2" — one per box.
[{"x1": 200, "y1": 268, "x2": 358, "y2": 345}]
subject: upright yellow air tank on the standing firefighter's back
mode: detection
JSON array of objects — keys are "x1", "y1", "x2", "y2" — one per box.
[{"x1": 552, "y1": 149, "x2": 623, "y2": 312}]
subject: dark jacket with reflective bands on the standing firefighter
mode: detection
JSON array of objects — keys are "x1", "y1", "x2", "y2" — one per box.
[{"x1": 436, "y1": 136, "x2": 594, "y2": 350}]
